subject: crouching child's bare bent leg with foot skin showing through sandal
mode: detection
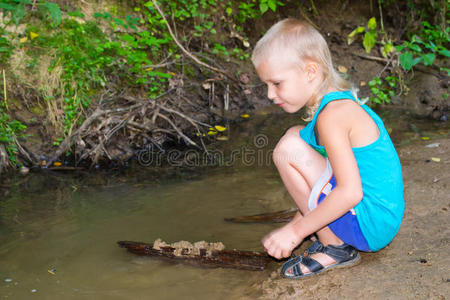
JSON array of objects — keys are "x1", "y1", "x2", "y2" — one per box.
[{"x1": 273, "y1": 126, "x2": 343, "y2": 273}]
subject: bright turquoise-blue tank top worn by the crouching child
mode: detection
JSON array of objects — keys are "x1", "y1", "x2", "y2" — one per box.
[{"x1": 300, "y1": 91, "x2": 405, "y2": 251}]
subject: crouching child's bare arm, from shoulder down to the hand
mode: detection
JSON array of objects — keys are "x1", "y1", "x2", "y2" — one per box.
[{"x1": 263, "y1": 103, "x2": 362, "y2": 258}]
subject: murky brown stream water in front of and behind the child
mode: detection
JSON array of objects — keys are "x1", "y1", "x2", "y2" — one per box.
[{"x1": 0, "y1": 104, "x2": 449, "y2": 299}]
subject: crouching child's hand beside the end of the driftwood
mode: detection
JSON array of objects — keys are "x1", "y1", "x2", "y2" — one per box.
[{"x1": 262, "y1": 223, "x2": 303, "y2": 259}]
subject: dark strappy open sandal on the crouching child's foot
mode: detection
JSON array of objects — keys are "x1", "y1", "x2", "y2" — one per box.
[{"x1": 281, "y1": 240, "x2": 361, "y2": 279}]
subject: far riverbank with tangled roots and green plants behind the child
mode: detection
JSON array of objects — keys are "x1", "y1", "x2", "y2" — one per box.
[{"x1": 0, "y1": 0, "x2": 449, "y2": 178}]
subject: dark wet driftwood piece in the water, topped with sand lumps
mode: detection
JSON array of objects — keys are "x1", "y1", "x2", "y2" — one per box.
[{"x1": 117, "y1": 241, "x2": 272, "y2": 271}]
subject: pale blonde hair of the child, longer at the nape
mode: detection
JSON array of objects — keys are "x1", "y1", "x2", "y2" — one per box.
[{"x1": 252, "y1": 18, "x2": 356, "y2": 121}]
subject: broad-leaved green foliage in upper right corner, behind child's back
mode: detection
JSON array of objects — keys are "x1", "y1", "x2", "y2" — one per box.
[{"x1": 347, "y1": 0, "x2": 450, "y2": 104}]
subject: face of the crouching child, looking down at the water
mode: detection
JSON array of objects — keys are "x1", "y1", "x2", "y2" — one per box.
[{"x1": 256, "y1": 58, "x2": 321, "y2": 113}]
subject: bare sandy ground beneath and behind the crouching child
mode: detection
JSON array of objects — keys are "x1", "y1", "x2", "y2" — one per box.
[{"x1": 251, "y1": 138, "x2": 450, "y2": 299}]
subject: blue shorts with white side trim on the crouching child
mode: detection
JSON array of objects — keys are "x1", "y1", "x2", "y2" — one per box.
[{"x1": 308, "y1": 159, "x2": 370, "y2": 252}]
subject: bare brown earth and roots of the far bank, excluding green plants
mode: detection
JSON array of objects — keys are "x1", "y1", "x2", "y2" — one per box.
[{"x1": 0, "y1": 1, "x2": 449, "y2": 175}]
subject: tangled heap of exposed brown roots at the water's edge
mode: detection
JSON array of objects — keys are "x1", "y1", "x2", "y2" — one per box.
[{"x1": 45, "y1": 90, "x2": 211, "y2": 167}]
